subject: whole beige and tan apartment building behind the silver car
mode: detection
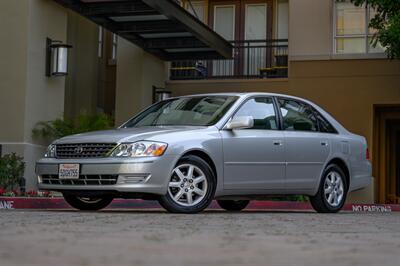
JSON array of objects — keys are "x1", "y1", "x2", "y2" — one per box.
[{"x1": 0, "y1": 0, "x2": 400, "y2": 202}]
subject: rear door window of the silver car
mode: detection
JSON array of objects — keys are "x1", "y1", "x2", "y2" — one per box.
[{"x1": 279, "y1": 99, "x2": 318, "y2": 131}]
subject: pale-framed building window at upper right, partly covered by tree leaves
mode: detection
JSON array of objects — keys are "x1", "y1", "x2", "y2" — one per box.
[{"x1": 334, "y1": 1, "x2": 384, "y2": 54}]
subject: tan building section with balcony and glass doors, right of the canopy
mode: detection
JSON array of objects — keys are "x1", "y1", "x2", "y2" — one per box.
[{"x1": 167, "y1": 0, "x2": 400, "y2": 202}]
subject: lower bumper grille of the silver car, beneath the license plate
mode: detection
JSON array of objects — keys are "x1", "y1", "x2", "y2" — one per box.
[{"x1": 41, "y1": 175, "x2": 118, "y2": 186}]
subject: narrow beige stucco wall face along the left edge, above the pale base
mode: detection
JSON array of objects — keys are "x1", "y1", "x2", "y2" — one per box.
[{"x1": 0, "y1": 1, "x2": 29, "y2": 142}]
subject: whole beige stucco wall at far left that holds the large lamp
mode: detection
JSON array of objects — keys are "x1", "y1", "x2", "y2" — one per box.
[{"x1": 0, "y1": 0, "x2": 67, "y2": 190}]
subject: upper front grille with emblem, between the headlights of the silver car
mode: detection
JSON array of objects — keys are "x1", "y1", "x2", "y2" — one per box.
[{"x1": 56, "y1": 143, "x2": 117, "y2": 159}]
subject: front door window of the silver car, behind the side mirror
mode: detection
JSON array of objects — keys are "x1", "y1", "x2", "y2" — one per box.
[{"x1": 234, "y1": 97, "x2": 278, "y2": 130}]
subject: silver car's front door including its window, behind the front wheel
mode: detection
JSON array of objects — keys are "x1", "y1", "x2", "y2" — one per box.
[{"x1": 221, "y1": 97, "x2": 285, "y2": 190}]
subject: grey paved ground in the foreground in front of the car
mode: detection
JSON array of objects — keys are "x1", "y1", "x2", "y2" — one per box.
[{"x1": 0, "y1": 210, "x2": 400, "y2": 266}]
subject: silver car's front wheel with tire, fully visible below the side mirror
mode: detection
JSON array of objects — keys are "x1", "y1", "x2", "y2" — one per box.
[{"x1": 159, "y1": 155, "x2": 216, "y2": 213}]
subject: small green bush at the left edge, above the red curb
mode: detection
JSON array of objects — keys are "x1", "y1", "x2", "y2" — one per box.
[{"x1": 0, "y1": 153, "x2": 25, "y2": 191}]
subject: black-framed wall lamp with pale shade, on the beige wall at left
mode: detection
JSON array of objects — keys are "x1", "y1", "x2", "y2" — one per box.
[{"x1": 46, "y1": 38, "x2": 72, "y2": 77}]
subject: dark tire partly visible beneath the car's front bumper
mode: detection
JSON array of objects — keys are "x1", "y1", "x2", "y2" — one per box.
[{"x1": 63, "y1": 194, "x2": 113, "y2": 211}]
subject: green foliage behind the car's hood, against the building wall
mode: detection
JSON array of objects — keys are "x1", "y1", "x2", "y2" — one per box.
[{"x1": 32, "y1": 112, "x2": 114, "y2": 142}]
